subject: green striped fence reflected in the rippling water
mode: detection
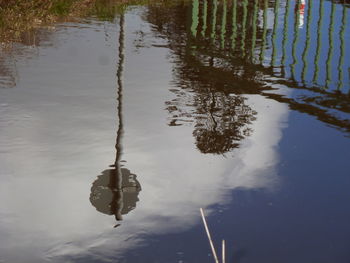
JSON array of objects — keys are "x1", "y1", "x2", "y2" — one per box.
[{"x1": 190, "y1": 0, "x2": 350, "y2": 93}]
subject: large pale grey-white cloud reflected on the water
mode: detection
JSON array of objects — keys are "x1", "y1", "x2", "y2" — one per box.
[{"x1": 0, "y1": 5, "x2": 288, "y2": 262}]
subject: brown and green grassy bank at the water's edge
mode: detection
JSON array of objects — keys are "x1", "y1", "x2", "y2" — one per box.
[{"x1": 0, "y1": 0, "x2": 152, "y2": 43}]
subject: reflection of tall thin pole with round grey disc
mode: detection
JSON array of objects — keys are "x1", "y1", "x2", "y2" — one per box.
[{"x1": 90, "y1": 14, "x2": 141, "y2": 226}]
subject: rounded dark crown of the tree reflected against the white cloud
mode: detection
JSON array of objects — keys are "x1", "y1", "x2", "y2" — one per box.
[{"x1": 167, "y1": 84, "x2": 256, "y2": 154}]
